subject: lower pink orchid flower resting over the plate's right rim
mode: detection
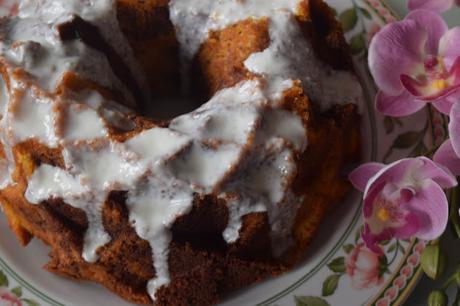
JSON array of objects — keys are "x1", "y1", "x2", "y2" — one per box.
[{"x1": 349, "y1": 157, "x2": 457, "y2": 252}]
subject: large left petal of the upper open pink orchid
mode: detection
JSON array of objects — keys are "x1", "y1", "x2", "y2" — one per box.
[{"x1": 369, "y1": 19, "x2": 427, "y2": 95}]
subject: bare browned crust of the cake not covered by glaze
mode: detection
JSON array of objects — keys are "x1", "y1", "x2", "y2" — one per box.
[{"x1": 0, "y1": 0, "x2": 360, "y2": 306}]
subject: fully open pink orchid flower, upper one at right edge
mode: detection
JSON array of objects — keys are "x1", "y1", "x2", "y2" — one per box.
[{"x1": 369, "y1": 10, "x2": 460, "y2": 116}]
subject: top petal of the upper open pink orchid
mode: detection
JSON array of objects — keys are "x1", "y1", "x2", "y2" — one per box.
[{"x1": 405, "y1": 9, "x2": 449, "y2": 55}]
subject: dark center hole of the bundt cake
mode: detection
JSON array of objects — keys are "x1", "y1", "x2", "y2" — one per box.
[{"x1": 117, "y1": 1, "x2": 223, "y2": 120}]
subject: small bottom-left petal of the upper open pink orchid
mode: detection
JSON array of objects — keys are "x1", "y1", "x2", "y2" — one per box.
[{"x1": 375, "y1": 90, "x2": 426, "y2": 117}]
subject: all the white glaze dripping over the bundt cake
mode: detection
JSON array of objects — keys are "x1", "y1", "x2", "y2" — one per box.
[{"x1": 0, "y1": 0, "x2": 366, "y2": 299}]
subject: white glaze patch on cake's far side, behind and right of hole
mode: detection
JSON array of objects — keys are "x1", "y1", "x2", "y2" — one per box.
[{"x1": 170, "y1": 0, "x2": 362, "y2": 111}]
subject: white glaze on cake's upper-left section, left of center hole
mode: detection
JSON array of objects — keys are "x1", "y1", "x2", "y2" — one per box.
[{"x1": 1, "y1": 0, "x2": 145, "y2": 105}]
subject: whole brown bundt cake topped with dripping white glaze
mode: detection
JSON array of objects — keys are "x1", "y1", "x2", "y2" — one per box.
[{"x1": 0, "y1": 0, "x2": 362, "y2": 306}]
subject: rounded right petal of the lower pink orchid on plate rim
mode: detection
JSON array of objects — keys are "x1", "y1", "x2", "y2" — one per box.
[{"x1": 407, "y1": 181, "x2": 449, "y2": 240}]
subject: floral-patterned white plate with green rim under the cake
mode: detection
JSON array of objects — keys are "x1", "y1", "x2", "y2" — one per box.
[{"x1": 0, "y1": 0, "x2": 446, "y2": 306}]
